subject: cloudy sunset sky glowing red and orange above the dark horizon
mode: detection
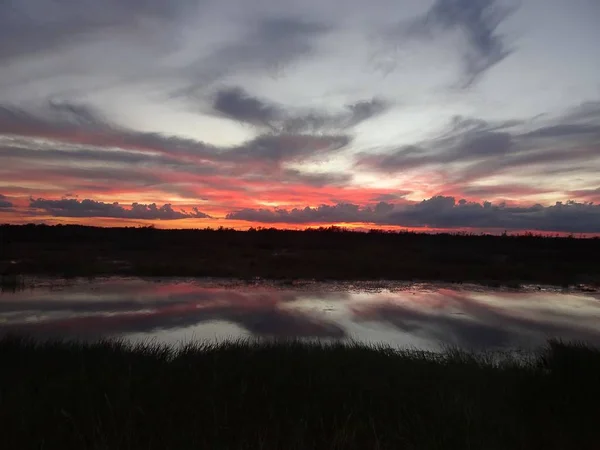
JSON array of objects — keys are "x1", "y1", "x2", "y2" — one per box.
[{"x1": 0, "y1": 0, "x2": 600, "y2": 234}]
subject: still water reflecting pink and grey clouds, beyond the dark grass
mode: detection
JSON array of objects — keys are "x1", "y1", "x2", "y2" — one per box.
[{"x1": 0, "y1": 278, "x2": 600, "y2": 350}]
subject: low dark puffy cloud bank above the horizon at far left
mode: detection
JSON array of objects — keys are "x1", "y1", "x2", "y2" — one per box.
[{"x1": 29, "y1": 198, "x2": 210, "y2": 220}]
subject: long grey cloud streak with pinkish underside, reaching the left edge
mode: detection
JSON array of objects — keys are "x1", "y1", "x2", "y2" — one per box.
[{"x1": 0, "y1": 102, "x2": 351, "y2": 170}]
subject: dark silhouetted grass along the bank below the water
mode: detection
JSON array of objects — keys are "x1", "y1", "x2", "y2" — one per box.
[{"x1": 0, "y1": 337, "x2": 600, "y2": 450}]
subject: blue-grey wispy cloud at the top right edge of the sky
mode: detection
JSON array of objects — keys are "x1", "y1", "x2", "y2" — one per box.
[{"x1": 387, "y1": 0, "x2": 515, "y2": 88}]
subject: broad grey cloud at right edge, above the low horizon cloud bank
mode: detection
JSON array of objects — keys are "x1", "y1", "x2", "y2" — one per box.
[{"x1": 356, "y1": 111, "x2": 600, "y2": 183}]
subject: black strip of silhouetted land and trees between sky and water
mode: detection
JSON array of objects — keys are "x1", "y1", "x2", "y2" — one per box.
[{"x1": 0, "y1": 225, "x2": 600, "y2": 287}]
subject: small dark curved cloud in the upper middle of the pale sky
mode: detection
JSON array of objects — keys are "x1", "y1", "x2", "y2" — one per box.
[{"x1": 213, "y1": 87, "x2": 389, "y2": 133}]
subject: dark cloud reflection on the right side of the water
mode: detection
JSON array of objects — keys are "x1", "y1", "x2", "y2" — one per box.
[{"x1": 354, "y1": 293, "x2": 600, "y2": 348}]
